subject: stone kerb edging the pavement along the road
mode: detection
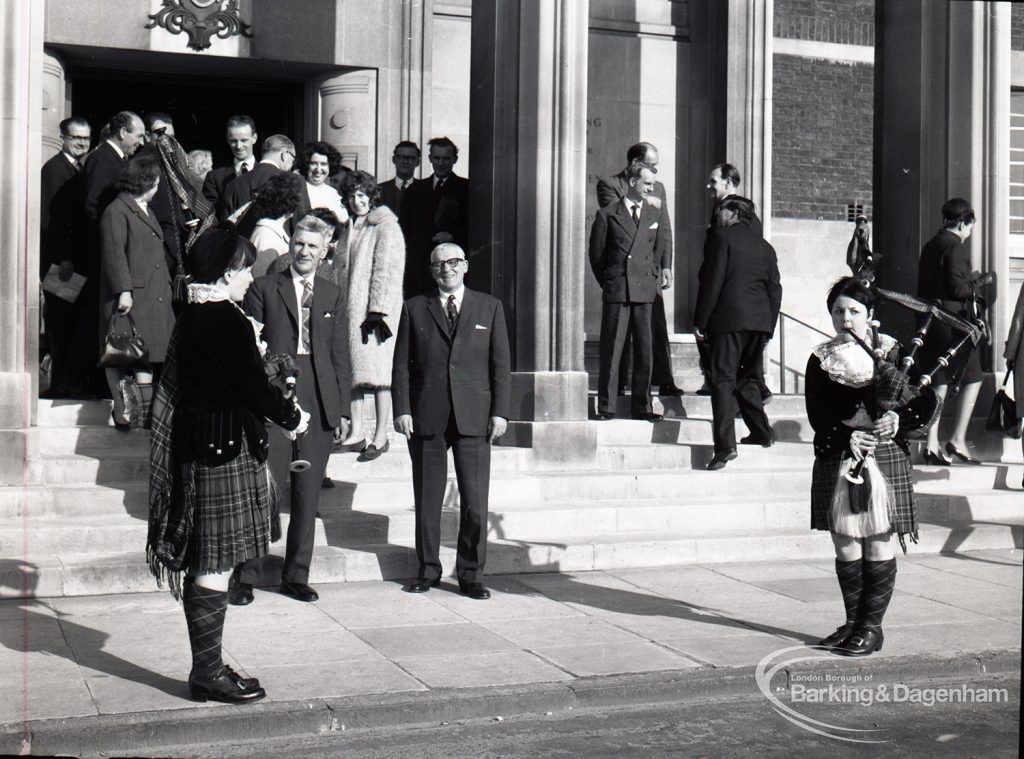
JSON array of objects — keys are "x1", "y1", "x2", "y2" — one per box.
[{"x1": 0, "y1": 641, "x2": 1021, "y2": 756}]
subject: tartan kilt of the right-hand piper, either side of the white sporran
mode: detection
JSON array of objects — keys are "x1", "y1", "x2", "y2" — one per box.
[{"x1": 811, "y1": 440, "x2": 918, "y2": 540}]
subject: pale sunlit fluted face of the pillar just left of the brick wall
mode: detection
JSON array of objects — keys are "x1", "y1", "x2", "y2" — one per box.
[{"x1": 725, "y1": 0, "x2": 773, "y2": 238}]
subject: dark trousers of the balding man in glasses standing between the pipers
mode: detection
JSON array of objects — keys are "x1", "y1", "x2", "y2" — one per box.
[{"x1": 409, "y1": 407, "x2": 490, "y2": 583}]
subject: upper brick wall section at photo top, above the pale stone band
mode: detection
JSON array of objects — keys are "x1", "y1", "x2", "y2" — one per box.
[{"x1": 774, "y1": 0, "x2": 874, "y2": 45}]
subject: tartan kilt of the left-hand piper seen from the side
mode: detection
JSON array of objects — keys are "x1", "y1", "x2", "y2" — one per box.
[{"x1": 193, "y1": 446, "x2": 278, "y2": 574}]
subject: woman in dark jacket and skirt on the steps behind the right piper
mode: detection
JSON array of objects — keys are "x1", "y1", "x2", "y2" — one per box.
[{"x1": 918, "y1": 198, "x2": 982, "y2": 465}]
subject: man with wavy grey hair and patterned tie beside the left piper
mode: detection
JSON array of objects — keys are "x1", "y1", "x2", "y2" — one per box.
[{"x1": 228, "y1": 216, "x2": 351, "y2": 605}]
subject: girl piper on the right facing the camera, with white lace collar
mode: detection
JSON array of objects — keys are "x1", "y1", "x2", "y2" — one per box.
[{"x1": 805, "y1": 277, "x2": 935, "y2": 656}]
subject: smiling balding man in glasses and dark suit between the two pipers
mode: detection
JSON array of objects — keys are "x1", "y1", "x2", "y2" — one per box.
[{"x1": 391, "y1": 243, "x2": 511, "y2": 600}]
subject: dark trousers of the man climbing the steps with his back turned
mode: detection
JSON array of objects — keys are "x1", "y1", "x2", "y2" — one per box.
[{"x1": 709, "y1": 332, "x2": 771, "y2": 453}]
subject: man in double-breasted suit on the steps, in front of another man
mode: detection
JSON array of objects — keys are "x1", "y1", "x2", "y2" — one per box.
[{"x1": 589, "y1": 162, "x2": 670, "y2": 422}]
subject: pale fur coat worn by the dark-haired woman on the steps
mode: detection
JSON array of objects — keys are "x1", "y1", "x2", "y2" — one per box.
[{"x1": 341, "y1": 206, "x2": 406, "y2": 388}]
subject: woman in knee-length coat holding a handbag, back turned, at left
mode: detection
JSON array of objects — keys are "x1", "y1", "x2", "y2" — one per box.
[{"x1": 99, "y1": 154, "x2": 174, "y2": 430}]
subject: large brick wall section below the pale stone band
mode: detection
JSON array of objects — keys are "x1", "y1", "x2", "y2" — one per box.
[{"x1": 772, "y1": 52, "x2": 874, "y2": 220}]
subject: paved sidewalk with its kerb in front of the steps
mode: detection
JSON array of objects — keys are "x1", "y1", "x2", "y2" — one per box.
[{"x1": 0, "y1": 547, "x2": 1022, "y2": 753}]
